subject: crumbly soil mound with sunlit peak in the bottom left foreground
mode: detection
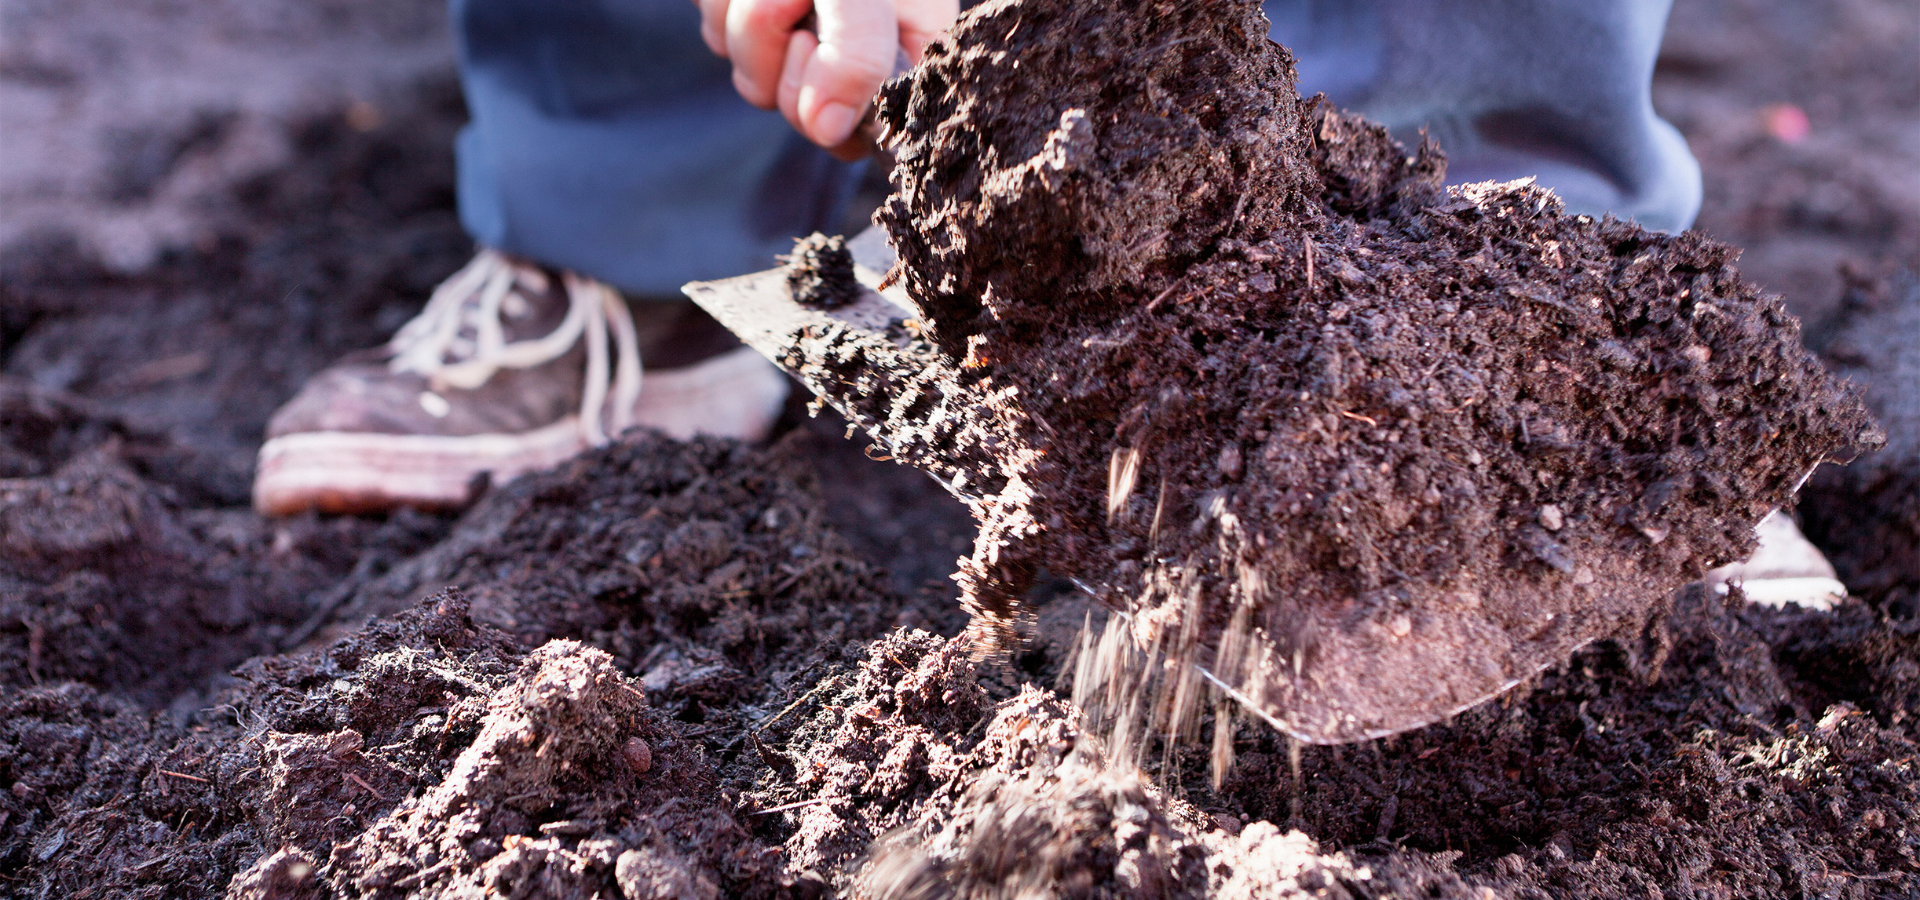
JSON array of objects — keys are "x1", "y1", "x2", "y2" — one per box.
[{"x1": 0, "y1": 593, "x2": 778, "y2": 898}]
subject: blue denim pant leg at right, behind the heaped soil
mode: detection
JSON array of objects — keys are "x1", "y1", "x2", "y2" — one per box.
[{"x1": 1265, "y1": 0, "x2": 1701, "y2": 230}]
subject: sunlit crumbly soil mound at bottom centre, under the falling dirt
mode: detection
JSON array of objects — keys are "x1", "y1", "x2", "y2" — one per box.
[{"x1": 753, "y1": 631, "x2": 1478, "y2": 898}]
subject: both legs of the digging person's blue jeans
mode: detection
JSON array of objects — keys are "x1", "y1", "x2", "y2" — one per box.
[{"x1": 453, "y1": 0, "x2": 1699, "y2": 297}]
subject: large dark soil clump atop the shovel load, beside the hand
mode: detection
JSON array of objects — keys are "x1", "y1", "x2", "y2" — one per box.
[{"x1": 877, "y1": 2, "x2": 1315, "y2": 347}]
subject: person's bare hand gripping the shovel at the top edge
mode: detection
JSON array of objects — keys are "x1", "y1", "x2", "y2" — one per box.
[{"x1": 695, "y1": 0, "x2": 960, "y2": 159}]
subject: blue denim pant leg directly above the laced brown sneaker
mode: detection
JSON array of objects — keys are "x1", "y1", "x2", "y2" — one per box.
[{"x1": 451, "y1": 0, "x2": 860, "y2": 297}]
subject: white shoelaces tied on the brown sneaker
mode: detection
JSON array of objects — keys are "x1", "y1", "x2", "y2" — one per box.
[{"x1": 388, "y1": 249, "x2": 641, "y2": 447}]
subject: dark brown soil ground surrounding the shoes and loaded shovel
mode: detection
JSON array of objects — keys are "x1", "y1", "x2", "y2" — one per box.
[{"x1": 0, "y1": 0, "x2": 1920, "y2": 898}]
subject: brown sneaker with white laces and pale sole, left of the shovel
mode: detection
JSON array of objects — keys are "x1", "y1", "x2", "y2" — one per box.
[{"x1": 253, "y1": 249, "x2": 787, "y2": 516}]
